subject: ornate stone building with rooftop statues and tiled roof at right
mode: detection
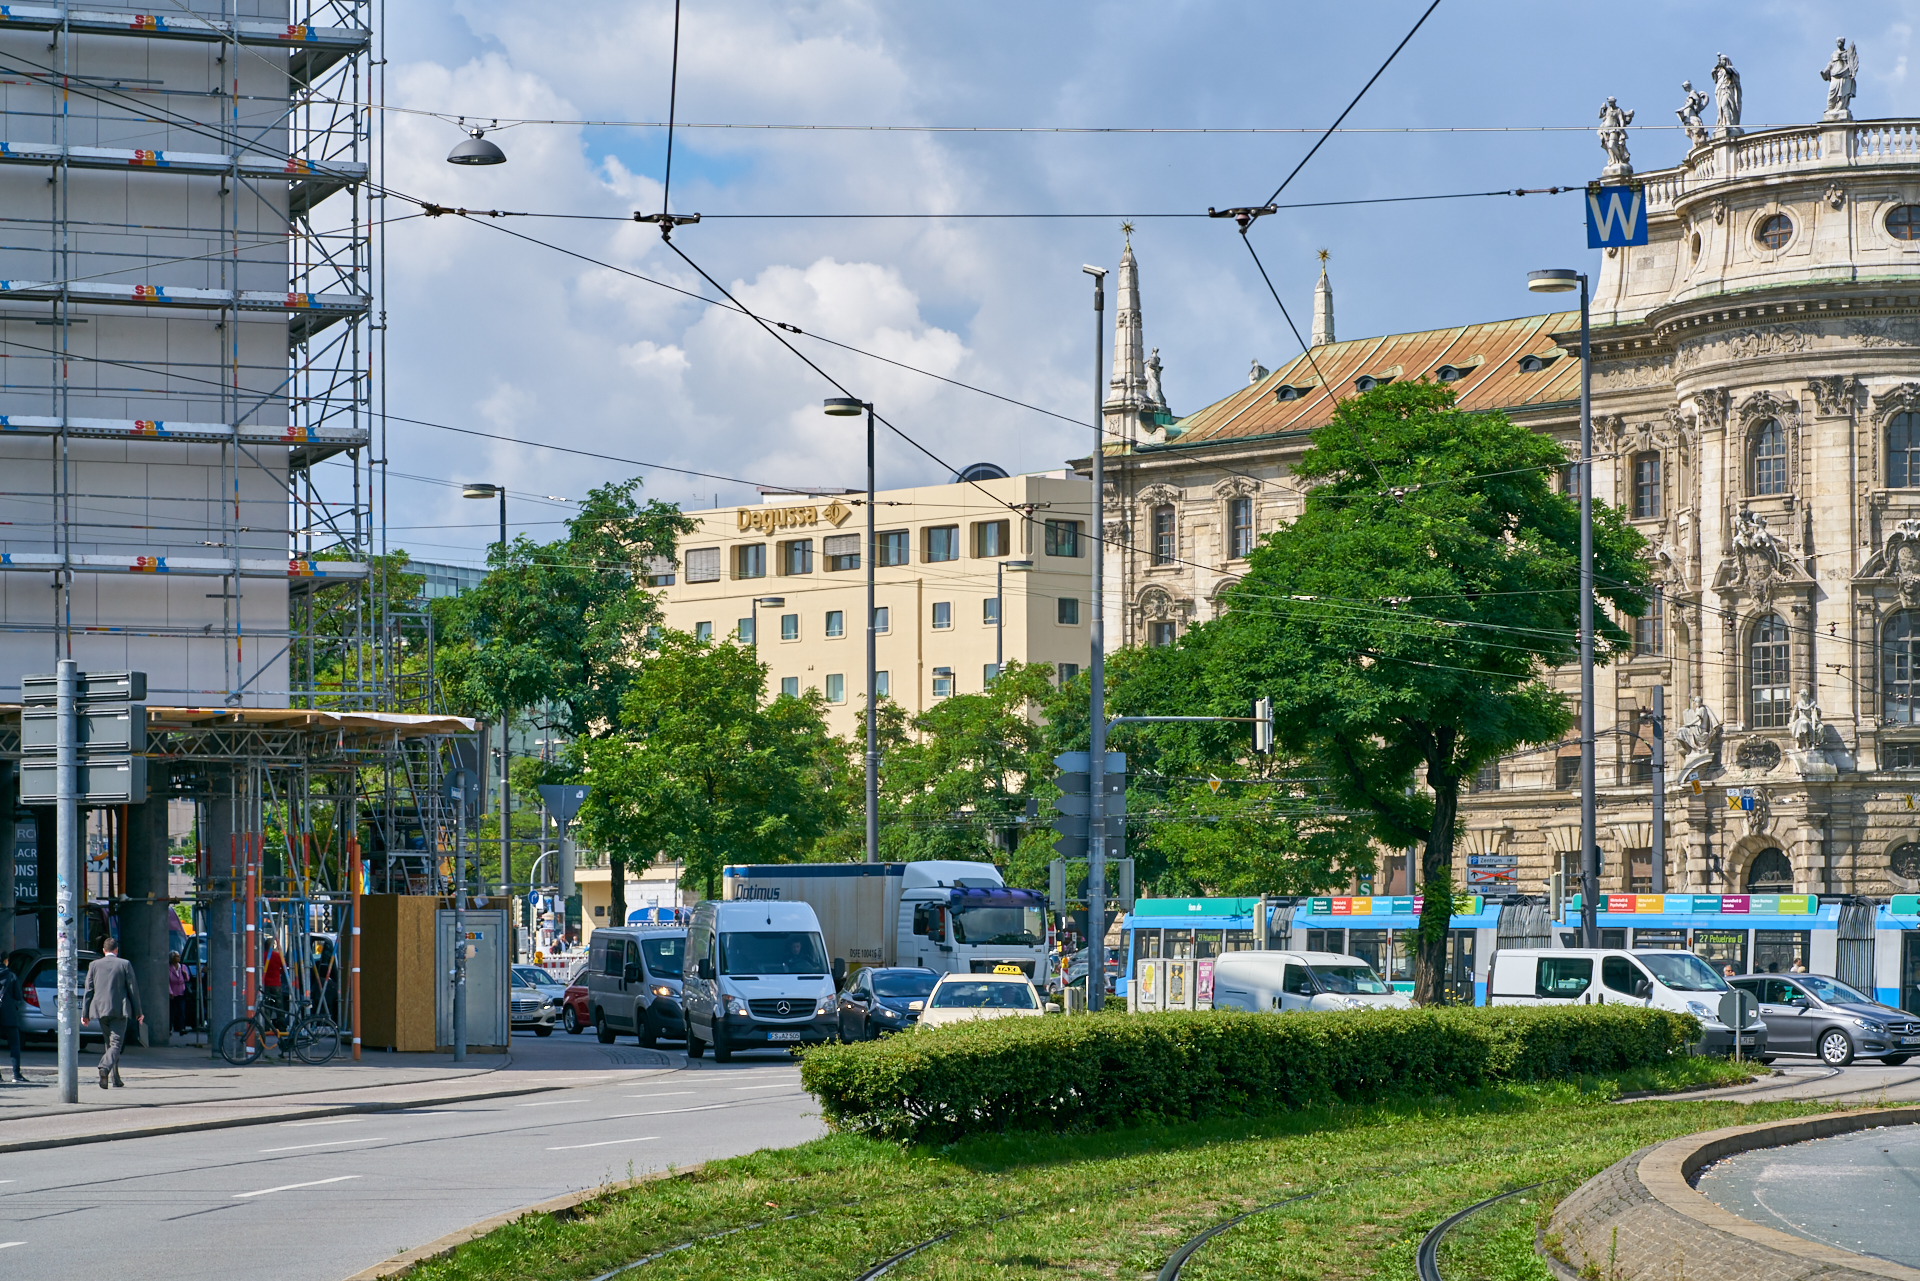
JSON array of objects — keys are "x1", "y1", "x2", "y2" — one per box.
[{"x1": 1106, "y1": 60, "x2": 1920, "y2": 895}]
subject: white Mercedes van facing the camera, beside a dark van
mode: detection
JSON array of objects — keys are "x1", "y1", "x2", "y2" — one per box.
[{"x1": 680, "y1": 901, "x2": 839, "y2": 1062}]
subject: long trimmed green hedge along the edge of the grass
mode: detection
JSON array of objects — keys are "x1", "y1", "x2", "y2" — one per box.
[{"x1": 801, "y1": 1004, "x2": 1699, "y2": 1139}]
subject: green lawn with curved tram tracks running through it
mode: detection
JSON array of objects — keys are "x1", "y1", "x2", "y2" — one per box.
[{"x1": 409, "y1": 1060, "x2": 1820, "y2": 1281}]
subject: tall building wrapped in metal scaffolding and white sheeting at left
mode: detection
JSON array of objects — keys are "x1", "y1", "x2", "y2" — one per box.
[{"x1": 0, "y1": 0, "x2": 472, "y2": 1033}]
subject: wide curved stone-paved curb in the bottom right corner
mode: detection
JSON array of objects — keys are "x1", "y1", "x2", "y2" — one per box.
[{"x1": 1542, "y1": 1106, "x2": 1920, "y2": 1281}]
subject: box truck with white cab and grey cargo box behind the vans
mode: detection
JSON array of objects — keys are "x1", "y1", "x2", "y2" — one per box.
[{"x1": 722, "y1": 860, "x2": 1050, "y2": 981}]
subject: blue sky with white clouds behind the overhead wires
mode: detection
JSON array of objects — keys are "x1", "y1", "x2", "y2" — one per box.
[{"x1": 362, "y1": 0, "x2": 1920, "y2": 563}]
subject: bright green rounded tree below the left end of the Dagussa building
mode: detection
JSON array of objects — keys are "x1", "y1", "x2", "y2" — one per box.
[{"x1": 572, "y1": 632, "x2": 847, "y2": 897}]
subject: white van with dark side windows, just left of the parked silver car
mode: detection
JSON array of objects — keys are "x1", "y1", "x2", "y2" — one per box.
[{"x1": 1486, "y1": 947, "x2": 1766, "y2": 1060}]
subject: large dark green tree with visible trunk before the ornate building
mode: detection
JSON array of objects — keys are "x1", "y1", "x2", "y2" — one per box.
[{"x1": 1196, "y1": 384, "x2": 1647, "y2": 1003}]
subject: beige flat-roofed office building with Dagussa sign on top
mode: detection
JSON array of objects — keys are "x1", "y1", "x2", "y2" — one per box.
[{"x1": 653, "y1": 467, "x2": 1092, "y2": 736}]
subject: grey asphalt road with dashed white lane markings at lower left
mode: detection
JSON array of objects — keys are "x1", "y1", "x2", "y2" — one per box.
[{"x1": 0, "y1": 1037, "x2": 826, "y2": 1281}]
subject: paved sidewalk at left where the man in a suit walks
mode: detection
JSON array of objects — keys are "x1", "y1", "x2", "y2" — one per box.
[{"x1": 0, "y1": 1037, "x2": 678, "y2": 1152}]
